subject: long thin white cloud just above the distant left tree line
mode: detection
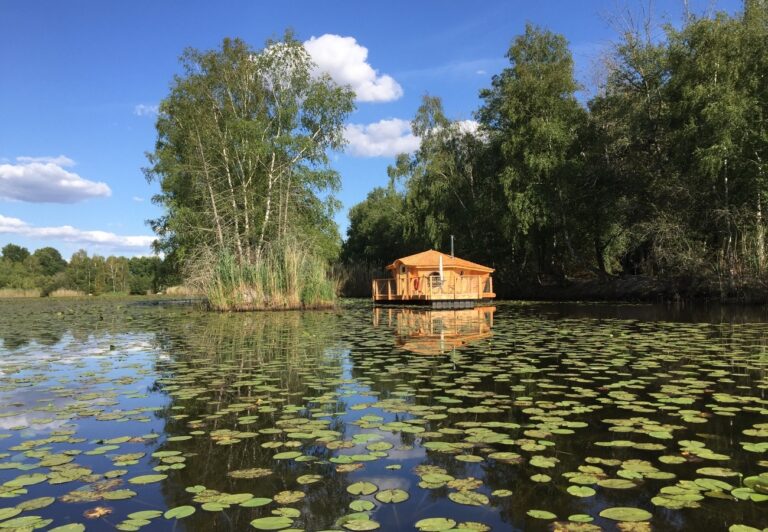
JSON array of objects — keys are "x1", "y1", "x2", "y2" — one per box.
[{"x1": 0, "y1": 214, "x2": 155, "y2": 251}]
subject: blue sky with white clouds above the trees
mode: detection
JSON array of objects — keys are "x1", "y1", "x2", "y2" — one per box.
[{"x1": 0, "y1": 0, "x2": 742, "y2": 258}]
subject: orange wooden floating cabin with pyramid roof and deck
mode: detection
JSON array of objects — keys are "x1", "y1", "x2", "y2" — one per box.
[{"x1": 371, "y1": 249, "x2": 496, "y2": 308}]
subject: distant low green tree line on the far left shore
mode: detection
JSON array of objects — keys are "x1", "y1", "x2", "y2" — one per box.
[{"x1": 0, "y1": 243, "x2": 172, "y2": 296}]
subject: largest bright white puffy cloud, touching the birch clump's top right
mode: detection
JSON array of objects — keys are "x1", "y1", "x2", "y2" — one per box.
[{"x1": 304, "y1": 33, "x2": 403, "y2": 102}]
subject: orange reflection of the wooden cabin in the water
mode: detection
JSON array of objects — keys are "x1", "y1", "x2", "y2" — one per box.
[{"x1": 373, "y1": 307, "x2": 496, "y2": 355}]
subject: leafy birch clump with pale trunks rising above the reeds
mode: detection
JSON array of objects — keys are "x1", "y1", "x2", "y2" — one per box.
[{"x1": 145, "y1": 34, "x2": 354, "y2": 262}]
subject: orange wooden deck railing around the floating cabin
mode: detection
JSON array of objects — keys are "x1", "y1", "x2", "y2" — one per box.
[{"x1": 371, "y1": 275, "x2": 494, "y2": 301}]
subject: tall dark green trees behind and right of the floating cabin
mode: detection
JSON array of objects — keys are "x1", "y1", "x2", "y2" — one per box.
[{"x1": 342, "y1": 0, "x2": 768, "y2": 293}]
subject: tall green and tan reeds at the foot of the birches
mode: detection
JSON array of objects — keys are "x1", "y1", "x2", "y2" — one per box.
[{"x1": 191, "y1": 241, "x2": 336, "y2": 311}]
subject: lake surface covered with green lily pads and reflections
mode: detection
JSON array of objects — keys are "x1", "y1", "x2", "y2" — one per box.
[{"x1": 0, "y1": 298, "x2": 768, "y2": 532}]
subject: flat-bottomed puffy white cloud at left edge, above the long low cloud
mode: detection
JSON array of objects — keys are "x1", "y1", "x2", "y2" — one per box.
[{"x1": 0, "y1": 155, "x2": 112, "y2": 203}]
